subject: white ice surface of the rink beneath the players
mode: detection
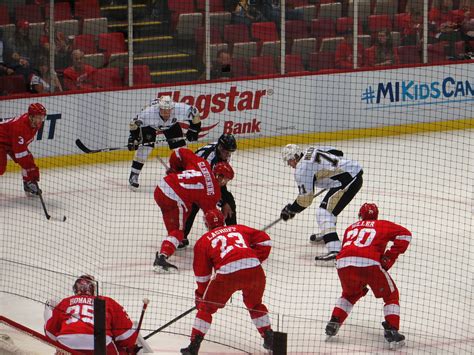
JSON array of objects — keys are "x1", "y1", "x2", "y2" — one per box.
[{"x1": 0, "y1": 130, "x2": 474, "y2": 354}]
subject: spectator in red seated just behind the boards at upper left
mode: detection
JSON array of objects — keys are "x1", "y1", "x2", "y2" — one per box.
[{"x1": 64, "y1": 49, "x2": 97, "y2": 90}]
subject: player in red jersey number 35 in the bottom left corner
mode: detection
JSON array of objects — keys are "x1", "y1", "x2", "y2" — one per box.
[{"x1": 44, "y1": 275, "x2": 138, "y2": 355}]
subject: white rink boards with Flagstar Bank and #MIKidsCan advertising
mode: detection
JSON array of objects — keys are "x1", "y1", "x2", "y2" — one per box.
[{"x1": 0, "y1": 64, "x2": 474, "y2": 157}]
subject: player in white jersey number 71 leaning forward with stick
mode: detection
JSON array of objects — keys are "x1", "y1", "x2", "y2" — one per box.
[{"x1": 280, "y1": 144, "x2": 363, "y2": 262}]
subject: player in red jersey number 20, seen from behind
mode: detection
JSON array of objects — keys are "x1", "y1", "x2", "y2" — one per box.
[{"x1": 326, "y1": 203, "x2": 412, "y2": 349}]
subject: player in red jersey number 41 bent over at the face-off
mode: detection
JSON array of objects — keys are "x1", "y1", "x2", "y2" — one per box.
[{"x1": 153, "y1": 147, "x2": 234, "y2": 272}]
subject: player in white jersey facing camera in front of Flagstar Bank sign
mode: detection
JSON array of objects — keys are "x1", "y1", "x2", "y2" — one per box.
[{"x1": 127, "y1": 96, "x2": 201, "y2": 190}]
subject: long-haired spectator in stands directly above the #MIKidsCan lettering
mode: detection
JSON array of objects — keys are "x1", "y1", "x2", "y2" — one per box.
[{"x1": 365, "y1": 30, "x2": 399, "y2": 67}]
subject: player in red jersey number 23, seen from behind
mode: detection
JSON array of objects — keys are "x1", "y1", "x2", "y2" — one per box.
[{"x1": 181, "y1": 209, "x2": 273, "y2": 355}]
